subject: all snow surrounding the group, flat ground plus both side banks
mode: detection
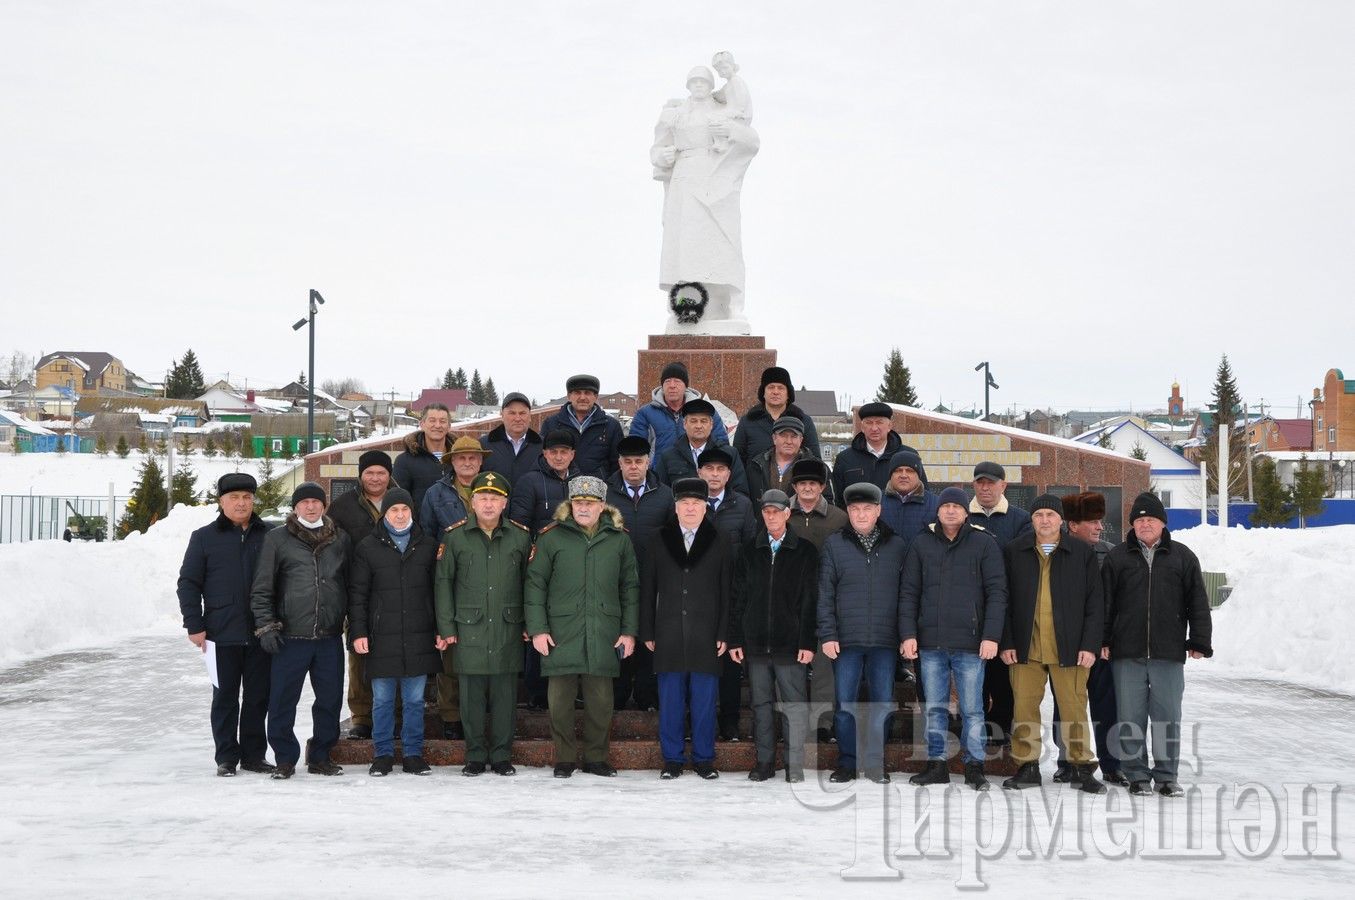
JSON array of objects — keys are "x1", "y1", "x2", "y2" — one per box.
[{"x1": 0, "y1": 508, "x2": 1355, "y2": 897}]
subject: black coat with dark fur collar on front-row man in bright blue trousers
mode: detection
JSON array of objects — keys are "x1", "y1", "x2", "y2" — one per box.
[{"x1": 640, "y1": 516, "x2": 734, "y2": 675}]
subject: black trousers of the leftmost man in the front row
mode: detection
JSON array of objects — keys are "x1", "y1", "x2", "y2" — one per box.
[{"x1": 211, "y1": 641, "x2": 272, "y2": 766}]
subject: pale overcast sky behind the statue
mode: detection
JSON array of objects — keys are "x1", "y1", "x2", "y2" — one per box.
[{"x1": 0, "y1": 0, "x2": 1355, "y2": 415}]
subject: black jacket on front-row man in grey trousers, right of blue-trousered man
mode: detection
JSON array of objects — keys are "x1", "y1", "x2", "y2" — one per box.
[{"x1": 729, "y1": 529, "x2": 818, "y2": 660}]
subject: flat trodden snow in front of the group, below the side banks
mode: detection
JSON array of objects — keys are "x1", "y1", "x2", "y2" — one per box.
[{"x1": 0, "y1": 636, "x2": 1355, "y2": 897}]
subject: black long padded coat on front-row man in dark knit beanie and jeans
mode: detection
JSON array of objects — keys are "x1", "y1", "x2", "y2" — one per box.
[{"x1": 348, "y1": 522, "x2": 442, "y2": 678}]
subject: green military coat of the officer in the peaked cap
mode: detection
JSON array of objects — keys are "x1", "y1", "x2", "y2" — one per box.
[{"x1": 434, "y1": 512, "x2": 531, "y2": 675}]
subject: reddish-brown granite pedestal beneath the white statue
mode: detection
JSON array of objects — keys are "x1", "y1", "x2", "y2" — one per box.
[{"x1": 635, "y1": 335, "x2": 776, "y2": 416}]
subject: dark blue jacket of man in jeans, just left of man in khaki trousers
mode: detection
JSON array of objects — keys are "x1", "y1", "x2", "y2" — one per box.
[{"x1": 898, "y1": 522, "x2": 1007, "y2": 653}]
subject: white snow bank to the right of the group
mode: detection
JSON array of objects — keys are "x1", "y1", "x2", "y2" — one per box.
[{"x1": 1172, "y1": 525, "x2": 1355, "y2": 694}]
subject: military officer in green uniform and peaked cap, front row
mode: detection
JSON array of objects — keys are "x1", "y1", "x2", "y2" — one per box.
[{"x1": 434, "y1": 472, "x2": 531, "y2": 775}]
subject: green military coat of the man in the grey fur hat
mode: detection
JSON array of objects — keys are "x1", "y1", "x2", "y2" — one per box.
[{"x1": 527, "y1": 502, "x2": 640, "y2": 678}]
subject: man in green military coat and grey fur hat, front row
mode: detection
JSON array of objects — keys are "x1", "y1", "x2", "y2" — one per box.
[{"x1": 526, "y1": 476, "x2": 640, "y2": 778}]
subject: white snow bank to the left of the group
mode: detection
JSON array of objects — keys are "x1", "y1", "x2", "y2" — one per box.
[{"x1": 0, "y1": 506, "x2": 217, "y2": 668}]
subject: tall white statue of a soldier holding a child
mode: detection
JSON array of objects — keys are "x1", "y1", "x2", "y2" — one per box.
[{"x1": 649, "y1": 52, "x2": 757, "y2": 335}]
